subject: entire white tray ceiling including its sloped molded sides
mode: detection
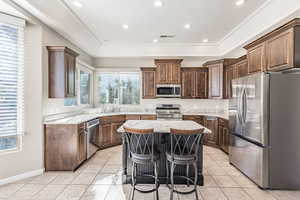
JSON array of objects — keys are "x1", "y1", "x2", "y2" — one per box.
[{"x1": 4, "y1": 0, "x2": 300, "y2": 57}]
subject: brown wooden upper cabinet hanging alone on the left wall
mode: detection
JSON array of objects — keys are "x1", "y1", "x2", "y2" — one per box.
[{"x1": 47, "y1": 46, "x2": 79, "y2": 98}]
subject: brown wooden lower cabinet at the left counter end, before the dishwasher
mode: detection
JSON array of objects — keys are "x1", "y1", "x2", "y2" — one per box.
[{"x1": 44, "y1": 124, "x2": 86, "y2": 171}]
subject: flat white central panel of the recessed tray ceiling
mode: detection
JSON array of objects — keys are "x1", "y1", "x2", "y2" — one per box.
[{"x1": 64, "y1": 0, "x2": 266, "y2": 44}]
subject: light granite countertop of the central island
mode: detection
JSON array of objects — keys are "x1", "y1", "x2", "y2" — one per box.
[{"x1": 118, "y1": 120, "x2": 211, "y2": 133}]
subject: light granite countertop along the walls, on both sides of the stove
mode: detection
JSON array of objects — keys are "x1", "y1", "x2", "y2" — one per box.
[{"x1": 44, "y1": 112, "x2": 228, "y2": 124}]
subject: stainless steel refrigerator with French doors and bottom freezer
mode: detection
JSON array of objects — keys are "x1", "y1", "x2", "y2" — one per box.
[{"x1": 229, "y1": 73, "x2": 300, "y2": 189}]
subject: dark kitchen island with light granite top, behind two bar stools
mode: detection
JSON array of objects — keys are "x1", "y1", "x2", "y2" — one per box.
[{"x1": 118, "y1": 120, "x2": 211, "y2": 185}]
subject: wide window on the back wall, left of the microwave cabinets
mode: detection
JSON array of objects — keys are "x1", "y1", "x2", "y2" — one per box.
[{"x1": 97, "y1": 73, "x2": 140, "y2": 104}]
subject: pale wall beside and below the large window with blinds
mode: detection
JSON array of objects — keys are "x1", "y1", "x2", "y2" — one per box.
[{"x1": 0, "y1": 24, "x2": 44, "y2": 180}]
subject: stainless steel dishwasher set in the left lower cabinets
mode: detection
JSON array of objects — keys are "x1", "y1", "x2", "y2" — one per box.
[{"x1": 86, "y1": 119, "x2": 100, "y2": 159}]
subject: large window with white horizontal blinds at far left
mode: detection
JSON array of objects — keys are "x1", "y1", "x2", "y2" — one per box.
[{"x1": 0, "y1": 14, "x2": 25, "y2": 152}]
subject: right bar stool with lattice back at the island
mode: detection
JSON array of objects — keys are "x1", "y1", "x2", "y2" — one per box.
[{"x1": 166, "y1": 129, "x2": 204, "y2": 200}]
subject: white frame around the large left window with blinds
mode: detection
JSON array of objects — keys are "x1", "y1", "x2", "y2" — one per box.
[{"x1": 0, "y1": 13, "x2": 26, "y2": 155}]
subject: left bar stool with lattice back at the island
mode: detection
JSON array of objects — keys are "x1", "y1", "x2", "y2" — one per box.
[{"x1": 124, "y1": 127, "x2": 160, "y2": 200}]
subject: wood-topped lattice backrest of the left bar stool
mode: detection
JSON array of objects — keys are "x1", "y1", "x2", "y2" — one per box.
[{"x1": 124, "y1": 127, "x2": 154, "y2": 159}]
